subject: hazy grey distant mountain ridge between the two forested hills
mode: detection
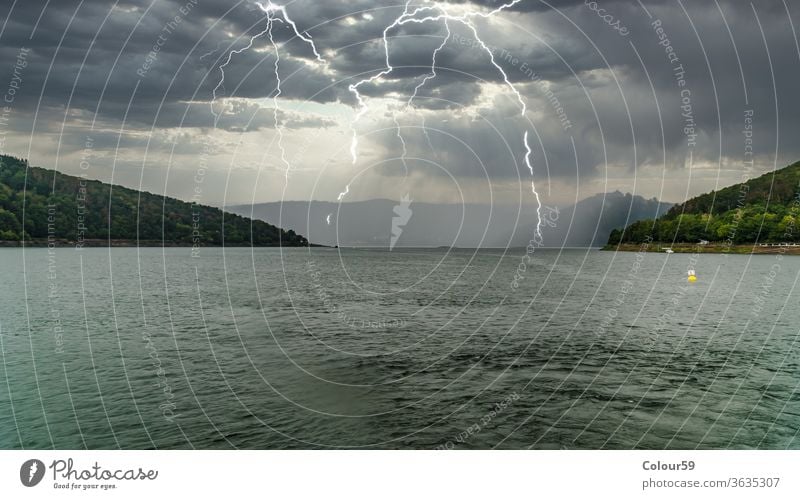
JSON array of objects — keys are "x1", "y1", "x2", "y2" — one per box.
[{"x1": 225, "y1": 192, "x2": 672, "y2": 252}]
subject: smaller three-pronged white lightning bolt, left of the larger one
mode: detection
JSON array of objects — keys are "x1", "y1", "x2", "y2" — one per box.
[{"x1": 211, "y1": 2, "x2": 326, "y2": 182}]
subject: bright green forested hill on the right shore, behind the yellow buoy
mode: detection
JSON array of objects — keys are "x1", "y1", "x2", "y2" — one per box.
[{"x1": 608, "y1": 162, "x2": 800, "y2": 245}]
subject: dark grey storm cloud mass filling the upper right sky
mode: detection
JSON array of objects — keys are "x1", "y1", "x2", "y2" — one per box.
[{"x1": 364, "y1": 2, "x2": 800, "y2": 188}]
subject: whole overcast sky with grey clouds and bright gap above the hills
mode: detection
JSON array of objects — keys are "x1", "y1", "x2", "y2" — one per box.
[{"x1": 0, "y1": 0, "x2": 800, "y2": 209}]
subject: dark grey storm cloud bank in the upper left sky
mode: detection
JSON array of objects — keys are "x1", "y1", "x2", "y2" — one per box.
[{"x1": 0, "y1": 0, "x2": 335, "y2": 127}]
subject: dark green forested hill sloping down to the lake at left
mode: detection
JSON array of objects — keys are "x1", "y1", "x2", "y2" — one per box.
[{"x1": 0, "y1": 156, "x2": 308, "y2": 246}]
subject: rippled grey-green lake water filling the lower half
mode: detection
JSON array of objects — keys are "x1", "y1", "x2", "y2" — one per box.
[{"x1": 0, "y1": 248, "x2": 800, "y2": 449}]
